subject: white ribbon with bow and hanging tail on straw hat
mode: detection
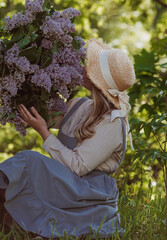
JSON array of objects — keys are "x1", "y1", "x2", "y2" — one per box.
[{"x1": 99, "y1": 50, "x2": 134, "y2": 150}]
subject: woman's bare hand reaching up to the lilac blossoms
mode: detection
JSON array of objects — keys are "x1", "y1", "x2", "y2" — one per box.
[{"x1": 18, "y1": 104, "x2": 51, "y2": 140}]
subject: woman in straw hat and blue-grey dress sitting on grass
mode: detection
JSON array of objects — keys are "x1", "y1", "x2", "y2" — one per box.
[{"x1": 0, "y1": 39, "x2": 135, "y2": 237}]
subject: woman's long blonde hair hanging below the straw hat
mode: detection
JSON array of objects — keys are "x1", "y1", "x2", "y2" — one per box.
[{"x1": 74, "y1": 86, "x2": 114, "y2": 143}]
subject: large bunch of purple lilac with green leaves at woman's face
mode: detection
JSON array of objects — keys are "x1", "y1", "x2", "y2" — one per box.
[{"x1": 0, "y1": 0, "x2": 85, "y2": 135}]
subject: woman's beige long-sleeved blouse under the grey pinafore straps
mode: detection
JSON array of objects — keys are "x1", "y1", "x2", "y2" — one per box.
[{"x1": 42, "y1": 98, "x2": 123, "y2": 177}]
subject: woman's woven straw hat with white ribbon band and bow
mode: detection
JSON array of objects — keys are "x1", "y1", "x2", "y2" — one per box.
[{"x1": 86, "y1": 38, "x2": 135, "y2": 110}]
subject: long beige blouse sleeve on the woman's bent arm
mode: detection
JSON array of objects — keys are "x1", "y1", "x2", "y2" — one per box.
[{"x1": 42, "y1": 118, "x2": 123, "y2": 176}]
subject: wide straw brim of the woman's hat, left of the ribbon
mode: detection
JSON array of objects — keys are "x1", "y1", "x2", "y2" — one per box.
[{"x1": 86, "y1": 38, "x2": 120, "y2": 109}]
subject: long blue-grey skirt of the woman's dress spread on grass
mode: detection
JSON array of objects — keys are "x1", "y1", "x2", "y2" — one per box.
[{"x1": 0, "y1": 150, "x2": 120, "y2": 238}]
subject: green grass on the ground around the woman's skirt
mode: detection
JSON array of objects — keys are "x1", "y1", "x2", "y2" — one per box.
[{"x1": 0, "y1": 191, "x2": 166, "y2": 240}]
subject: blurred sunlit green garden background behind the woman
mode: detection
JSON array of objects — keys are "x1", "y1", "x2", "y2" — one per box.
[{"x1": 0, "y1": 0, "x2": 167, "y2": 240}]
